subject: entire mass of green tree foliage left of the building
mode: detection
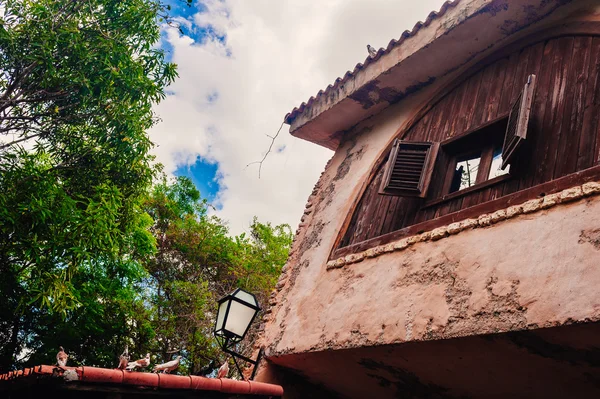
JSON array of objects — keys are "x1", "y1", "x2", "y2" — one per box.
[{"x1": 0, "y1": 0, "x2": 292, "y2": 374}]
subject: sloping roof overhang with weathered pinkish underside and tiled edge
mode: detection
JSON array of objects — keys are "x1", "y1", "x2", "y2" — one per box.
[{"x1": 285, "y1": 0, "x2": 584, "y2": 150}]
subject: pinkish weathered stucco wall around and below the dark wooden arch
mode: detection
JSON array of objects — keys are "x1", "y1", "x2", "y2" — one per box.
[{"x1": 261, "y1": 84, "x2": 600, "y2": 362}]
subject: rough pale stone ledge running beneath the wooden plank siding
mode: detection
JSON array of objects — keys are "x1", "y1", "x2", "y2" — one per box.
[{"x1": 327, "y1": 182, "x2": 600, "y2": 270}]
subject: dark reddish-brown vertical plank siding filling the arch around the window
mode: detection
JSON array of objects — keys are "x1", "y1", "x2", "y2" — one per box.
[{"x1": 340, "y1": 36, "x2": 600, "y2": 247}]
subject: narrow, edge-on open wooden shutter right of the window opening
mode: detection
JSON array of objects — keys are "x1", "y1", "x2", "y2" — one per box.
[{"x1": 502, "y1": 75, "x2": 535, "y2": 170}]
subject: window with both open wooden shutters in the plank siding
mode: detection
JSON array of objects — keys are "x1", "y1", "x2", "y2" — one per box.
[{"x1": 379, "y1": 75, "x2": 535, "y2": 198}]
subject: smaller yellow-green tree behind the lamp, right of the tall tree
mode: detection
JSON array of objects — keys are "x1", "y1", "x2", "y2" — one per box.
[{"x1": 145, "y1": 177, "x2": 292, "y2": 374}]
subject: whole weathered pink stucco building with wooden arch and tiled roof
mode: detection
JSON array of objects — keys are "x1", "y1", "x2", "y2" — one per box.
[{"x1": 258, "y1": 0, "x2": 600, "y2": 398}]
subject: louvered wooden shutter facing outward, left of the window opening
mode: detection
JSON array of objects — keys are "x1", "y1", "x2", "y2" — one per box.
[{"x1": 379, "y1": 139, "x2": 439, "y2": 198}]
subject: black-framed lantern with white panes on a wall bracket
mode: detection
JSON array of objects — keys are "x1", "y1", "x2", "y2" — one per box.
[{"x1": 214, "y1": 288, "x2": 262, "y2": 380}]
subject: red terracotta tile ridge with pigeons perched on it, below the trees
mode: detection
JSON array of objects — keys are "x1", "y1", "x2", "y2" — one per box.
[{"x1": 0, "y1": 365, "x2": 283, "y2": 397}]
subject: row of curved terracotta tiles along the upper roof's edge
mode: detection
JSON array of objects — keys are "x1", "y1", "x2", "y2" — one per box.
[{"x1": 285, "y1": 0, "x2": 460, "y2": 124}]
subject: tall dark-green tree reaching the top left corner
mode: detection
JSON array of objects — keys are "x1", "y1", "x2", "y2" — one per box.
[{"x1": 0, "y1": 0, "x2": 176, "y2": 370}]
